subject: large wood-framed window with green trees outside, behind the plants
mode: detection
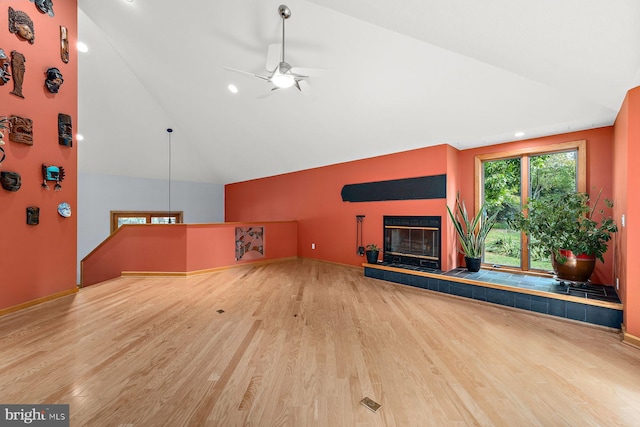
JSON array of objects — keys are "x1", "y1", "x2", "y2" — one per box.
[{"x1": 475, "y1": 140, "x2": 586, "y2": 271}]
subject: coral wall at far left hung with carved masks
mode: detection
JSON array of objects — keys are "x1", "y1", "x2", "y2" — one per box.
[{"x1": 0, "y1": 0, "x2": 78, "y2": 309}]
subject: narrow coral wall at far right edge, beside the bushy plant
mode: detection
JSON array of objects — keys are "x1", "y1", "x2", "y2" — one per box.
[{"x1": 613, "y1": 87, "x2": 640, "y2": 343}]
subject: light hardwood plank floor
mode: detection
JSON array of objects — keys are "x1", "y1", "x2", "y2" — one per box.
[{"x1": 0, "y1": 260, "x2": 640, "y2": 427}]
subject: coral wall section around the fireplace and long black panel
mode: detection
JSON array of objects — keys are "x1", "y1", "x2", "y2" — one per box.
[{"x1": 225, "y1": 145, "x2": 455, "y2": 269}]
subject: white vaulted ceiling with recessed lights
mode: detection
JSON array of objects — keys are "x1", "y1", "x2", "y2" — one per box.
[{"x1": 78, "y1": 0, "x2": 640, "y2": 184}]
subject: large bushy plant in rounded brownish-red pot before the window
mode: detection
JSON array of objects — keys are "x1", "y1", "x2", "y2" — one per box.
[{"x1": 512, "y1": 189, "x2": 618, "y2": 283}]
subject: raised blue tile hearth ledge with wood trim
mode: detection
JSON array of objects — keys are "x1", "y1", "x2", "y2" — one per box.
[{"x1": 364, "y1": 264, "x2": 622, "y2": 329}]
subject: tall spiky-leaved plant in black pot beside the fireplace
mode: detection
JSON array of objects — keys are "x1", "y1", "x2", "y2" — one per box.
[{"x1": 447, "y1": 193, "x2": 497, "y2": 271}]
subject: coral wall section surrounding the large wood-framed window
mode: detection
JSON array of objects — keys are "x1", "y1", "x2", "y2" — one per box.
[{"x1": 458, "y1": 126, "x2": 620, "y2": 284}]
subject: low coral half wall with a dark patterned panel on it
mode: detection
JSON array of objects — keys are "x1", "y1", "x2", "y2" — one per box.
[{"x1": 81, "y1": 221, "x2": 298, "y2": 286}]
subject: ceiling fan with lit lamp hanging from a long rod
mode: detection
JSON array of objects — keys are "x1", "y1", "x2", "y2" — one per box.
[{"x1": 224, "y1": 4, "x2": 314, "y2": 93}]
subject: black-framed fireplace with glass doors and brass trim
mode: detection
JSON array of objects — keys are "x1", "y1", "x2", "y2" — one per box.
[{"x1": 383, "y1": 216, "x2": 442, "y2": 270}]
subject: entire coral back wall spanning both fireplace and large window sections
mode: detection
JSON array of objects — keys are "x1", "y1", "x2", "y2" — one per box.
[{"x1": 225, "y1": 127, "x2": 613, "y2": 283}]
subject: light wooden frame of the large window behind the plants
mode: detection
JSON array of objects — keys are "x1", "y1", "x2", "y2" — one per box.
[{"x1": 474, "y1": 139, "x2": 587, "y2": 273}]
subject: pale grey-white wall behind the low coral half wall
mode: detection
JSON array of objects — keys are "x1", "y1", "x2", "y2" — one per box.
[{"x1": 78, "y1": 173, "x2": 224, "y2": 283}]
